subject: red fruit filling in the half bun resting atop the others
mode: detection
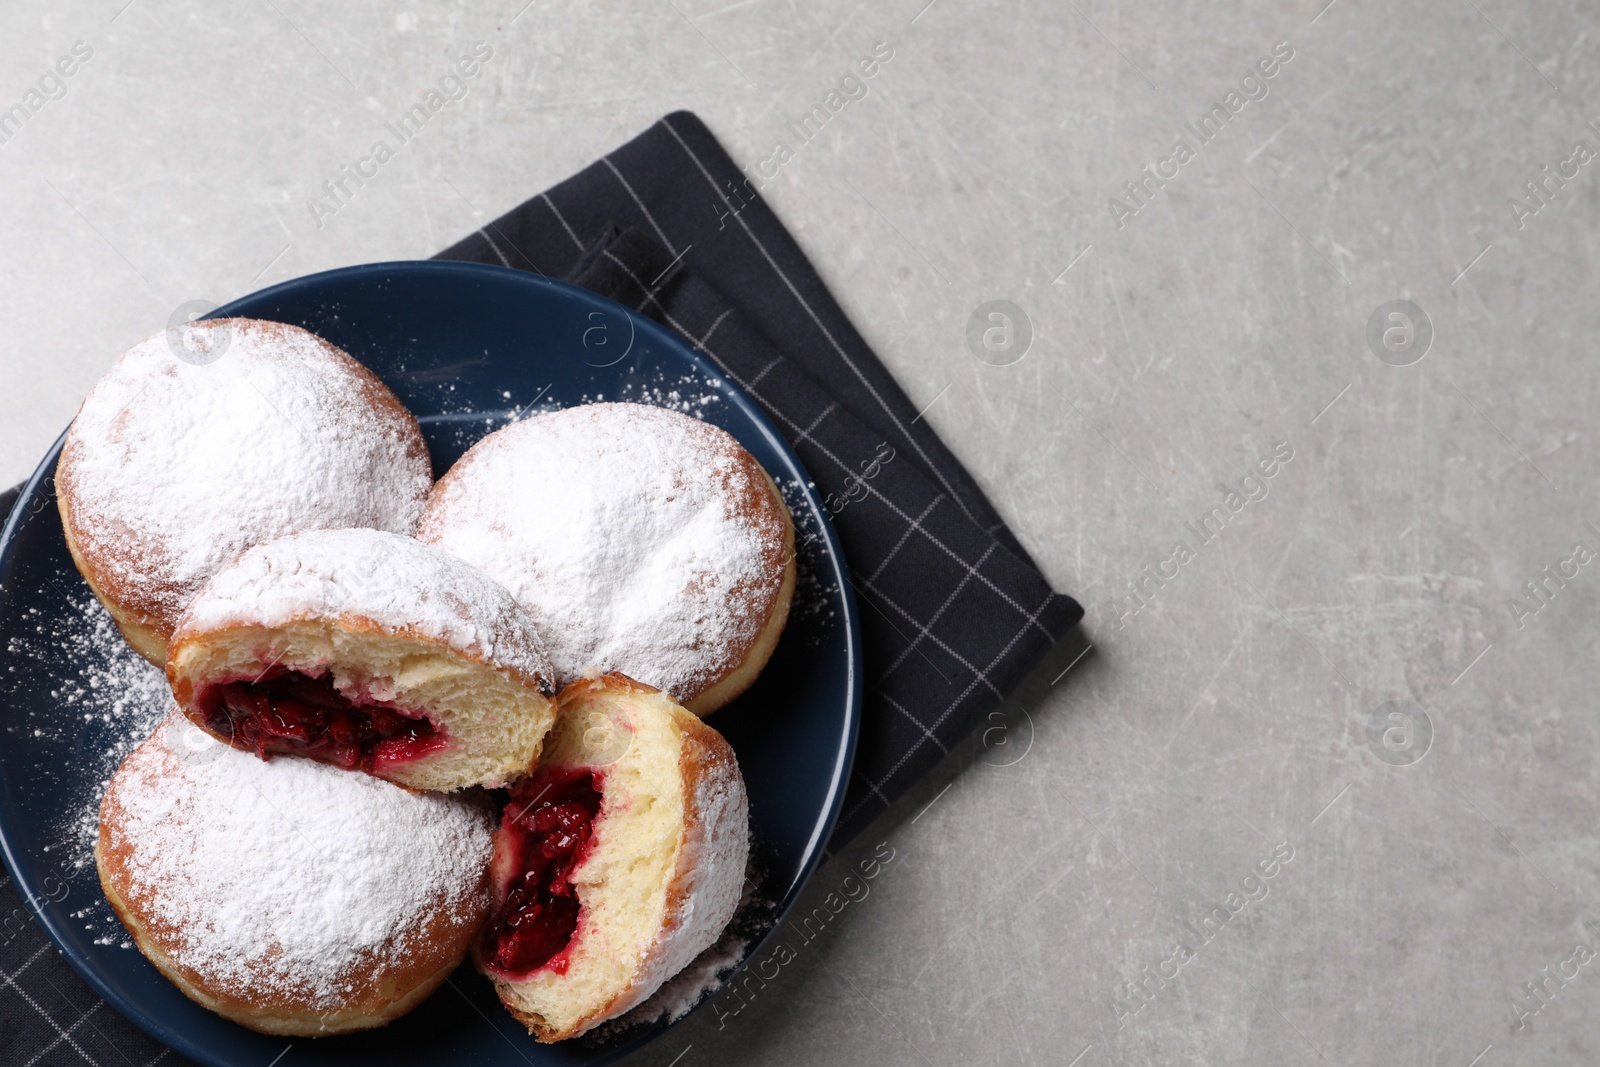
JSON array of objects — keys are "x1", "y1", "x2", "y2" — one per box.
[{"x1": 195, "y1": 669, "x2": 446, "y2": 771}]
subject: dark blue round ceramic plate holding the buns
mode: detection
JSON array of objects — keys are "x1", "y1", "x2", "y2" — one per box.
[{"x1": 0, "y1": 262, "x2": 861, "y2": 1067}]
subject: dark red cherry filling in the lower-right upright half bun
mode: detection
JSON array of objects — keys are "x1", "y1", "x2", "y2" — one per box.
[{"x1": 483, "y1": 771, "x2": 600, "y2": 976}]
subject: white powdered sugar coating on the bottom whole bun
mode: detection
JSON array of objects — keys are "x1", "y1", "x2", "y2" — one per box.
[{"x1": 109, "y1": 717, "x2": 491, "y2": 1008}]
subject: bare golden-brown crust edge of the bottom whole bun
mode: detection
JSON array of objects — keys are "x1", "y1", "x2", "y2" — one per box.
[{"x1": 94, "y1": 718, "x2": 490, "y2": 1037}]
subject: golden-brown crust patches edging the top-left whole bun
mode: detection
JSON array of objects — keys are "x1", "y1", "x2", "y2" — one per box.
[{"x1": 56, "y1": 318, "x2": 430, "y2": 665}]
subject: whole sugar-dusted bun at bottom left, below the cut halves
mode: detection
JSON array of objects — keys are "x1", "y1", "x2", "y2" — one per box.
[{"x1": 94, "y1": 710, "x2": 493, "y2": 1037}]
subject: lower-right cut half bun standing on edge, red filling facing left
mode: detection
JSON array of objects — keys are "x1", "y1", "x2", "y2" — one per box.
[{"x1": 474, "y1": 673, "x2": 749, "y2": 1041}]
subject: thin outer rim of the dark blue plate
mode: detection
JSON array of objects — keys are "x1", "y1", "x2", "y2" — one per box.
[{"x1": 0, "y1": 259, "x2": 864, "y2": 1067}]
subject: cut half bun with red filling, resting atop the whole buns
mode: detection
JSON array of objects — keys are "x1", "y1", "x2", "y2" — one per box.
[{"x1": 166, "y1": 530, "x2": 555, "y2": 790}]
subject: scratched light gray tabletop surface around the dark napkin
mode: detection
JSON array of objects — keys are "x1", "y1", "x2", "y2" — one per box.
[{"x1": 0, "y1": 0, "x2": 1600, "y2": 1067}]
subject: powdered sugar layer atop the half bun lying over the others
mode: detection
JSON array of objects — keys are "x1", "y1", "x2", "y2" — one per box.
[{"x1": 174, "y1": 530, "x2": 552, "y2": 683}]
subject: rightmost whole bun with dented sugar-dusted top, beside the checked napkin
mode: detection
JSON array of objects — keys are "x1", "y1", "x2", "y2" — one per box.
[{"x1": 418, "y1": 403, "x2": 795, "y2": 715}]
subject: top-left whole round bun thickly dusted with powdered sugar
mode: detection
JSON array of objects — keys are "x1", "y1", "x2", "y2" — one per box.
[{"x1": 56, "y1": 318, "x2": 432, "y2": 665}]
